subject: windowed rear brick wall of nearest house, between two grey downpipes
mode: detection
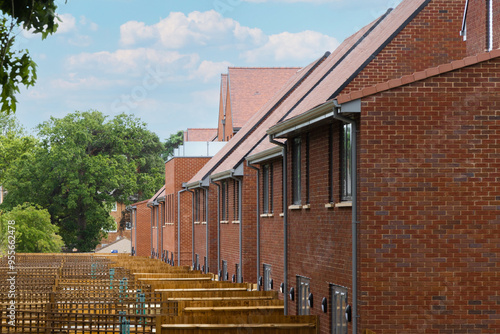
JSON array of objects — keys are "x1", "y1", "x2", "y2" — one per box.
[{"x1": 287, "y1": 123, "x2": 351, "y2": 333}]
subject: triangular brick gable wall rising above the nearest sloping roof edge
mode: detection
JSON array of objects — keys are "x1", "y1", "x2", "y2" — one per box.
[{"x1": 342, "y1": 0, "x2": 466, "y2": 94}]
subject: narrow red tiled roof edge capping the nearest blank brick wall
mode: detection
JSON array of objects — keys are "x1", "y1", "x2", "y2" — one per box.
[{"x1": 337, "y1": 49, "x2": 500, "y2": 104}]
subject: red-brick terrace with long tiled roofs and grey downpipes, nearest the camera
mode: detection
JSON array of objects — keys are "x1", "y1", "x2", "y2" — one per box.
[{"x1": 133, "y1": 0, "x2": 500, "y2": 333}]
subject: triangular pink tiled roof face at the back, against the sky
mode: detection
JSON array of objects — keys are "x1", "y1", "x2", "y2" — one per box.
[{"x1": 227, "y1": 67, "x2": 300, "y2": 129}]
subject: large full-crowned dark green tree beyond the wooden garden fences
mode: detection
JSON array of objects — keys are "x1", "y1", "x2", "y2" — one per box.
[{"x1": 4, "y1": 111, "x2": 165, "y2": 251}]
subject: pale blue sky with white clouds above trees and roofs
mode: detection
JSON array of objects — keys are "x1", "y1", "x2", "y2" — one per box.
[{"x1": 16, "y1": 0, "x2": 401, "y2": 140}]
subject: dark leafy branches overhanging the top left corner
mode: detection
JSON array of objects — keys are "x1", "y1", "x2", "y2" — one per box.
[{"x1": 0, "y1": 0, "x2": 58, "y2": 113}]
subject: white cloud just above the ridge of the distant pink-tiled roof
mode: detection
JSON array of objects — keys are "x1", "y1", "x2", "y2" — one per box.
[{"x1": 242, "y1": 30, "x2": 339, "y2": 63}]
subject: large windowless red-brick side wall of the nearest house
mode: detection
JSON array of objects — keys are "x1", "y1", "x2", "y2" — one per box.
[{"x1": 359, "y1": 58, "x2": 500, "y2": 334}]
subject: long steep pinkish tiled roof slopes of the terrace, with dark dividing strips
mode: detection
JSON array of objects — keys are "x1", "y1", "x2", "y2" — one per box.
[{"x1": 188, "y1": 0, "x2": 428, "y2": 184}]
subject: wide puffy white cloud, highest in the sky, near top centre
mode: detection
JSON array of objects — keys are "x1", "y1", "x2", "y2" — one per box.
[{"x1": 120, "y1": 10, "x2": 266, "y2": 49}]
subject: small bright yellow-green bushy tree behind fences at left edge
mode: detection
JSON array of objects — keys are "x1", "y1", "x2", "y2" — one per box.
[{"x1": 0, "y1": 203, "x2": 64, "y2": 254}]
